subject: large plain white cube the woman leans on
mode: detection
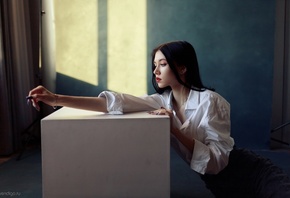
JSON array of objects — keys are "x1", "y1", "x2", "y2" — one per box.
[{"x1": 41, "y1": 108, "x2": 170, "y2": 198}]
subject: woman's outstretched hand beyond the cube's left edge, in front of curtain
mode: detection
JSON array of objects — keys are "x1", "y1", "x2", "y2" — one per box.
[{"x1": 28, "y1": 86, "x2": 58, "y2": 111}]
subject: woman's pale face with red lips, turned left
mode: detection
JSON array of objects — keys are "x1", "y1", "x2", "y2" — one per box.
[{"x1": 153, "y1": 50, "x2": 180, "y2": 88}]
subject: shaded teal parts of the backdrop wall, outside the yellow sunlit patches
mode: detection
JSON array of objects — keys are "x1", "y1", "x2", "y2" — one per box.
[{"x1": 56, "y1": 0, "x2": 275, "y2": 148}]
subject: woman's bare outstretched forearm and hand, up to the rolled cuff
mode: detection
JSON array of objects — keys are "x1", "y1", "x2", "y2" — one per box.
[{"x1": 28, "y1": 86, "x2": 107, "y2": 112}]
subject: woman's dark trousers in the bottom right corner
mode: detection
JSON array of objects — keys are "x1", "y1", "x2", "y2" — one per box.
[{"x1": 200, "y1": 148, "x2": 290, "y2": 198}]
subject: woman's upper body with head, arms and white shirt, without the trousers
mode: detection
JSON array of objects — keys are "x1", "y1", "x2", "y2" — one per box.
[{"x1": 29, "y1": 41, "x2": 234, "y2": 174}]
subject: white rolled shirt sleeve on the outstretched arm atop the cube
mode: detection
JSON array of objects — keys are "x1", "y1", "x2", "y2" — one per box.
[{"x1": 99, "y1": 91, "x2": 166, "y2": 114}]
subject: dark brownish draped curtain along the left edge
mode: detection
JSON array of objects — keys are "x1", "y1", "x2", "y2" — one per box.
[{"x1": 0, "y1": 0, "x2": 41, "y2": 155}]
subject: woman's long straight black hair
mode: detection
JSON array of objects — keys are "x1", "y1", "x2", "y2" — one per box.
[{"x1": 152, "y1": 41, "x2": 209, "y2": 94}]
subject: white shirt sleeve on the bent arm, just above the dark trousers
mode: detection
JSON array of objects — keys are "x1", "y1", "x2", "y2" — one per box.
[{"x1": 190, "y1": 94, "x2": 234, "y2": 174}]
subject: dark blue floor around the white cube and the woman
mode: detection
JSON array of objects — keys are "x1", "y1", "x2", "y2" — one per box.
[{"x1": 0, "y1": 147, "x2": 290, "y2": 198}]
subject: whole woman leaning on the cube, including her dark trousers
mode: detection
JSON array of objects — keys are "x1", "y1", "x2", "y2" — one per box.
[{"x1": 28, "y1": 41, "x2": 290, "y2": 198}]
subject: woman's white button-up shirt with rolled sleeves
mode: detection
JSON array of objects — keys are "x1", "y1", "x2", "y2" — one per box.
[{"x1": 99, "y1": 90, "x2": 234, "y2": 174}]
